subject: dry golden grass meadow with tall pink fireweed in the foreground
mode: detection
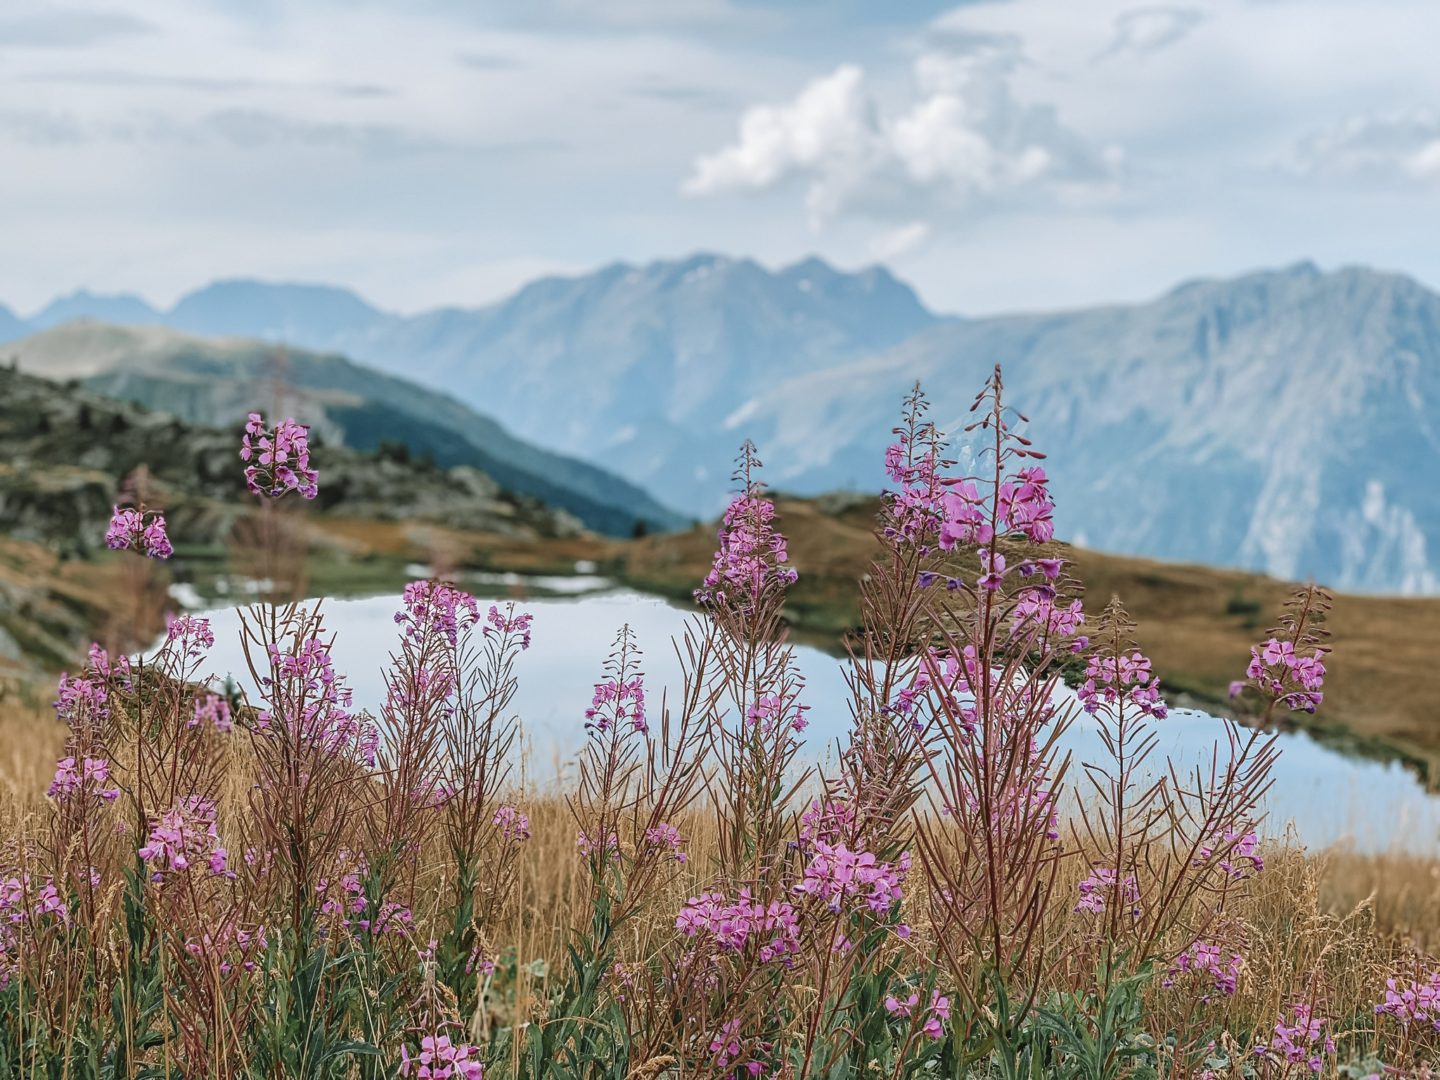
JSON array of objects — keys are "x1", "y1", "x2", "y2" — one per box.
[{"x1": 0, "y1": 372, "x2": 1440, "y2": 1080}]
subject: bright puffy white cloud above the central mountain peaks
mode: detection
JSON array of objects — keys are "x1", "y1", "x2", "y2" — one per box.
[{"x1": 683, "y1": 37, "x2": 1119, "y2": 226}]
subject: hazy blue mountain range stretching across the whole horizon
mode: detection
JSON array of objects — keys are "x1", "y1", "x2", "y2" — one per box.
[{"x1": 0, "y1": 255, "x2": 1440, "y2": 593}]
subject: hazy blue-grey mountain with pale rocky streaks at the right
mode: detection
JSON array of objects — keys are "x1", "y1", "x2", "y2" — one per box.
[{"x1": 746, "y1": 264, "x2": 1440, "y2": 592}]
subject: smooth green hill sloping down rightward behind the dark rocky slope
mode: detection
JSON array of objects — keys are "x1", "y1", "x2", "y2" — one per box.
[{"x1": 0, "y1": 321, "x2": 680, "y2": 534}]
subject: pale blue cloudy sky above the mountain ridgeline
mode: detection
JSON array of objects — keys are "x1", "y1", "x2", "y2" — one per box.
[{"x1": 0, "y1": 0, "x2": 1440, "y2": 315}]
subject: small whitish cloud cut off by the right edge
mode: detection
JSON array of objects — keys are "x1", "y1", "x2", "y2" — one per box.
[{"x1": 1280, "y1": 109, "x2": 1440, "y2": 181}]
